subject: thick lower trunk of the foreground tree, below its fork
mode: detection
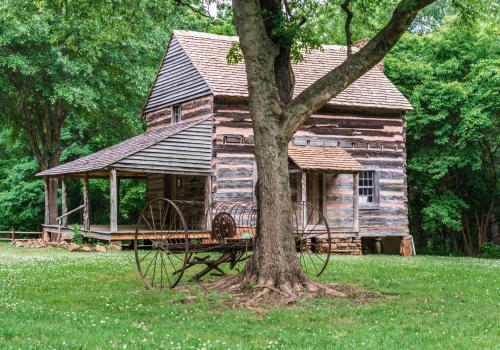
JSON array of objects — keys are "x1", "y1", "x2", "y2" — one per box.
[{"x1": 246, "y1": 117, "x2": 308, "y2": 291}]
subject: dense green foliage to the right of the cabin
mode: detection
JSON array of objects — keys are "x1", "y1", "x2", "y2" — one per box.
[{"x1": 386, "y1": 18, "x2": 500, "y2": 255}]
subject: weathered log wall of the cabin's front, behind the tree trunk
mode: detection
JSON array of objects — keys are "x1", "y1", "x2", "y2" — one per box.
[{"x1": 213, "y1": 101, "x2": 408, "y2": 236}]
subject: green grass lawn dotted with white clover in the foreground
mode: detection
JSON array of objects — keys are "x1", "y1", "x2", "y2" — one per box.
[{"x1": 0, "y1": 244, "x2": 500, "y2": 350}]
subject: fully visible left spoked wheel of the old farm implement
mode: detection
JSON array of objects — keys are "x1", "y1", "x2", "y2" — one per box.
[{"x1": 134, "y1": 198, "x2": 189, "y2": 289}]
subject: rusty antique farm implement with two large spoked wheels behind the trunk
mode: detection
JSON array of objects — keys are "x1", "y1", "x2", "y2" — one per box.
[{"x1": 134, "y1": 198, "x2": 331, "y2": 289}]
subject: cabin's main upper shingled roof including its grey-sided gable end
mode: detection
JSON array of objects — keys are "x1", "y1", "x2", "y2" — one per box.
[{"x1": 143, "y1": 30, "x2": 412, "y2": 113}]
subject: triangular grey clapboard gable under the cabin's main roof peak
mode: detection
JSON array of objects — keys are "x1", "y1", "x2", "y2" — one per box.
[{"x1": 143, "y1": 36, "x2": 211, "y2": 113}]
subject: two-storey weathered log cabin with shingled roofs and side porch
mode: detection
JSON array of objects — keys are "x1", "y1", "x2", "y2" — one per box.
[{"x1": 38, "y1": 31, "x2": 412, "y2": 255}]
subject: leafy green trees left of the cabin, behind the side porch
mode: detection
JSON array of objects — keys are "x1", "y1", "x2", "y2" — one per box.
[{"x1": 0, "y1": 0, "x2": 230, "y2": 229}]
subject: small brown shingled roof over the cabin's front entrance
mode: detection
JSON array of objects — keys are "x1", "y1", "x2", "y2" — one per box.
[{"x1": 288, "y1": 145, "x2": 363, "y2": 173}]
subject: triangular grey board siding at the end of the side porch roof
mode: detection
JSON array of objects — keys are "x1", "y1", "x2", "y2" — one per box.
[{"x1": 113, "y1": 118, "x2": 212, "y2": 175}]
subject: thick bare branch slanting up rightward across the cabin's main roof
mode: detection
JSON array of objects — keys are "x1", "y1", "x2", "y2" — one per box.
[{"x1": 285, "y1": 0, "x2": 435, "y2": 138}]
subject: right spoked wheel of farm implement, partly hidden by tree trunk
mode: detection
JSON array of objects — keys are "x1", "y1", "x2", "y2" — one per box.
[{"x1": 294, "y1": 202, "x2": 332, "y2": 276}]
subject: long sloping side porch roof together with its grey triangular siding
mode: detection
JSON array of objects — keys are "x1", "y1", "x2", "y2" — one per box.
[{"x1": 37, "y1": 117, "x2": 212, "y2": 176}]
